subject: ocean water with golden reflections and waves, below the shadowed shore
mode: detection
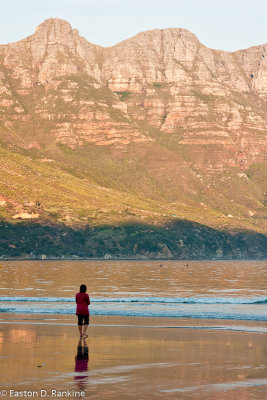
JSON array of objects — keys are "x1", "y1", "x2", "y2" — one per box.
[{"x1": 0, "y1": 261, "x2": 267, "y2": 321}]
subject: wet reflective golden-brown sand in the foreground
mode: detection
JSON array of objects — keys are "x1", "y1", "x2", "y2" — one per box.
[{"x1": 0, "y1": 313, "x2": 267, "y2": 400}]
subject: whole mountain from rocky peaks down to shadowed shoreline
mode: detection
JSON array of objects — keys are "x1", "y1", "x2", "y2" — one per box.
[{"x1": 0, "y1": 18, "x2": 267, "y2": 258}]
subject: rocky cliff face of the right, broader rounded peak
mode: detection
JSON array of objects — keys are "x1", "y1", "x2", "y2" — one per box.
[{"x1": 103, "y1": 29, "x2": 267, "y2": 169}]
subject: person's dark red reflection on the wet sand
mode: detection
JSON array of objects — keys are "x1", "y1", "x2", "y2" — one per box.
[{"x1": 75, "y1": 339, "x2": 89, "y2": 390}]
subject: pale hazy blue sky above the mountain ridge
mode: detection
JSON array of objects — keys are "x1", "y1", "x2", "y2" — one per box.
[{"x1": 0, "y1": 0, "x2": 267, "y2": 51}]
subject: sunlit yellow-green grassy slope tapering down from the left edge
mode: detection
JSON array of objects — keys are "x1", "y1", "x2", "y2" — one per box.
[{"x1": 0, "y1": 146, "x2": 166, "y2": 224}]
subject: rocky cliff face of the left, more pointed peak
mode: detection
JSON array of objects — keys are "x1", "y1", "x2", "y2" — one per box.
[{"x1": 0, "y1": 19, "x2": 151, "y2": 147}]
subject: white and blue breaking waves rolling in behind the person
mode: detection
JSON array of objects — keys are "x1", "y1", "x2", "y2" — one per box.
[{"x1": 0, "y1": 296, "x2": 267, "y2": 321}]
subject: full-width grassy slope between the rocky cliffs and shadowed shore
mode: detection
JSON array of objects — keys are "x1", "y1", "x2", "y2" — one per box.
[{"x1": 0, "y1": 139, "x2": 264, "y2": 232}]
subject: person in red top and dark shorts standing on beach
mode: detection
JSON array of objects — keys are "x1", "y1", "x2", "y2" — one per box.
[{"x1": 76, "y1": 285, "x2": 90, "y2": 338}]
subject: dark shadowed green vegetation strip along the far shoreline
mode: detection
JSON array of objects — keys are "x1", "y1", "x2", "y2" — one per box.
[{"x1": 0, "y1": 220, "x2": 267, "y2": 259}]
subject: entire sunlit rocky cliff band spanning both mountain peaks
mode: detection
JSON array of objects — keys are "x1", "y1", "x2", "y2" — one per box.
[{"x1": 0, "y1": 18, "x2": 267, "y2": 171}]
